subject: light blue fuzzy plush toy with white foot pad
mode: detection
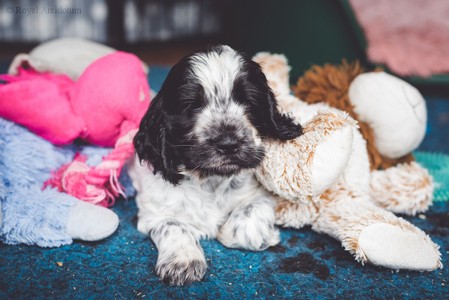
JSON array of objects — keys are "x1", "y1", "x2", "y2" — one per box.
[{"x1": 0, "y1": 119, "x2": 118, "y2": 247}]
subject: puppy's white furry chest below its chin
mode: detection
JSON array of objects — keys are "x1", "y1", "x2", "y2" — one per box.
[{"x1": 129, "y1": 160, "x2": 257, "y2": 237}]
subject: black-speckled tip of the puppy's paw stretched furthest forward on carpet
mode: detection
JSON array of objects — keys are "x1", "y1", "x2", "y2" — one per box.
[{"x1": 156, "y1": 257, "x2": 207, "y2": 285}]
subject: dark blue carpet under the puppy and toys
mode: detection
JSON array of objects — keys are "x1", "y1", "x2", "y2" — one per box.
[{"x1": 0, "y1": 62, "x2": 449, "y2": 299}]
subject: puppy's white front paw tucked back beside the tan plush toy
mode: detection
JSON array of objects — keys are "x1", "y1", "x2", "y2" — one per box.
[{"x1": 217, "y1": 206, "x2": 280, "y2": 251}]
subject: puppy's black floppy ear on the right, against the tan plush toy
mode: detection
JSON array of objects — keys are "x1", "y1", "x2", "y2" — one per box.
[{"x1": 240, "y1": 60, "x2": 302, "y2": 140}]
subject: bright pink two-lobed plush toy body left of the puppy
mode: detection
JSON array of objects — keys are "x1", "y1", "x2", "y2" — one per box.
[{"x1": 0, "y1": 52, "x2": 150, "y2": 147}]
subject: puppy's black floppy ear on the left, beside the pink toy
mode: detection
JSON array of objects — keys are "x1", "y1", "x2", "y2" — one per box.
[{"x1": 134, "y1": 89, "x2": 183, "y2": 185}]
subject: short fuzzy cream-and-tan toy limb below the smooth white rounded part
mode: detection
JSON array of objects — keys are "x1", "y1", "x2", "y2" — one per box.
[{"x1": 370, "y1": 162, "x2": 433, "y2": 215}]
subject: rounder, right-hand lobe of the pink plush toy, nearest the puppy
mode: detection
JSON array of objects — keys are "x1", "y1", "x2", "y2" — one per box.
[{"x1": 72, "y1": 52, "x2": 150, "y2": 147}]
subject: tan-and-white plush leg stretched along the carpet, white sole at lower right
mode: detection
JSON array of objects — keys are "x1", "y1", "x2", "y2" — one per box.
[{"x1": 312, "y1": 185, "x2": 442, "y2": 271}]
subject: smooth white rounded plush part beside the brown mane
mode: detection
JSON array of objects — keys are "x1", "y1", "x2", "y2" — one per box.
[{"x1": 348, "y1": 72, "x2": 427, "y2": 158}]
